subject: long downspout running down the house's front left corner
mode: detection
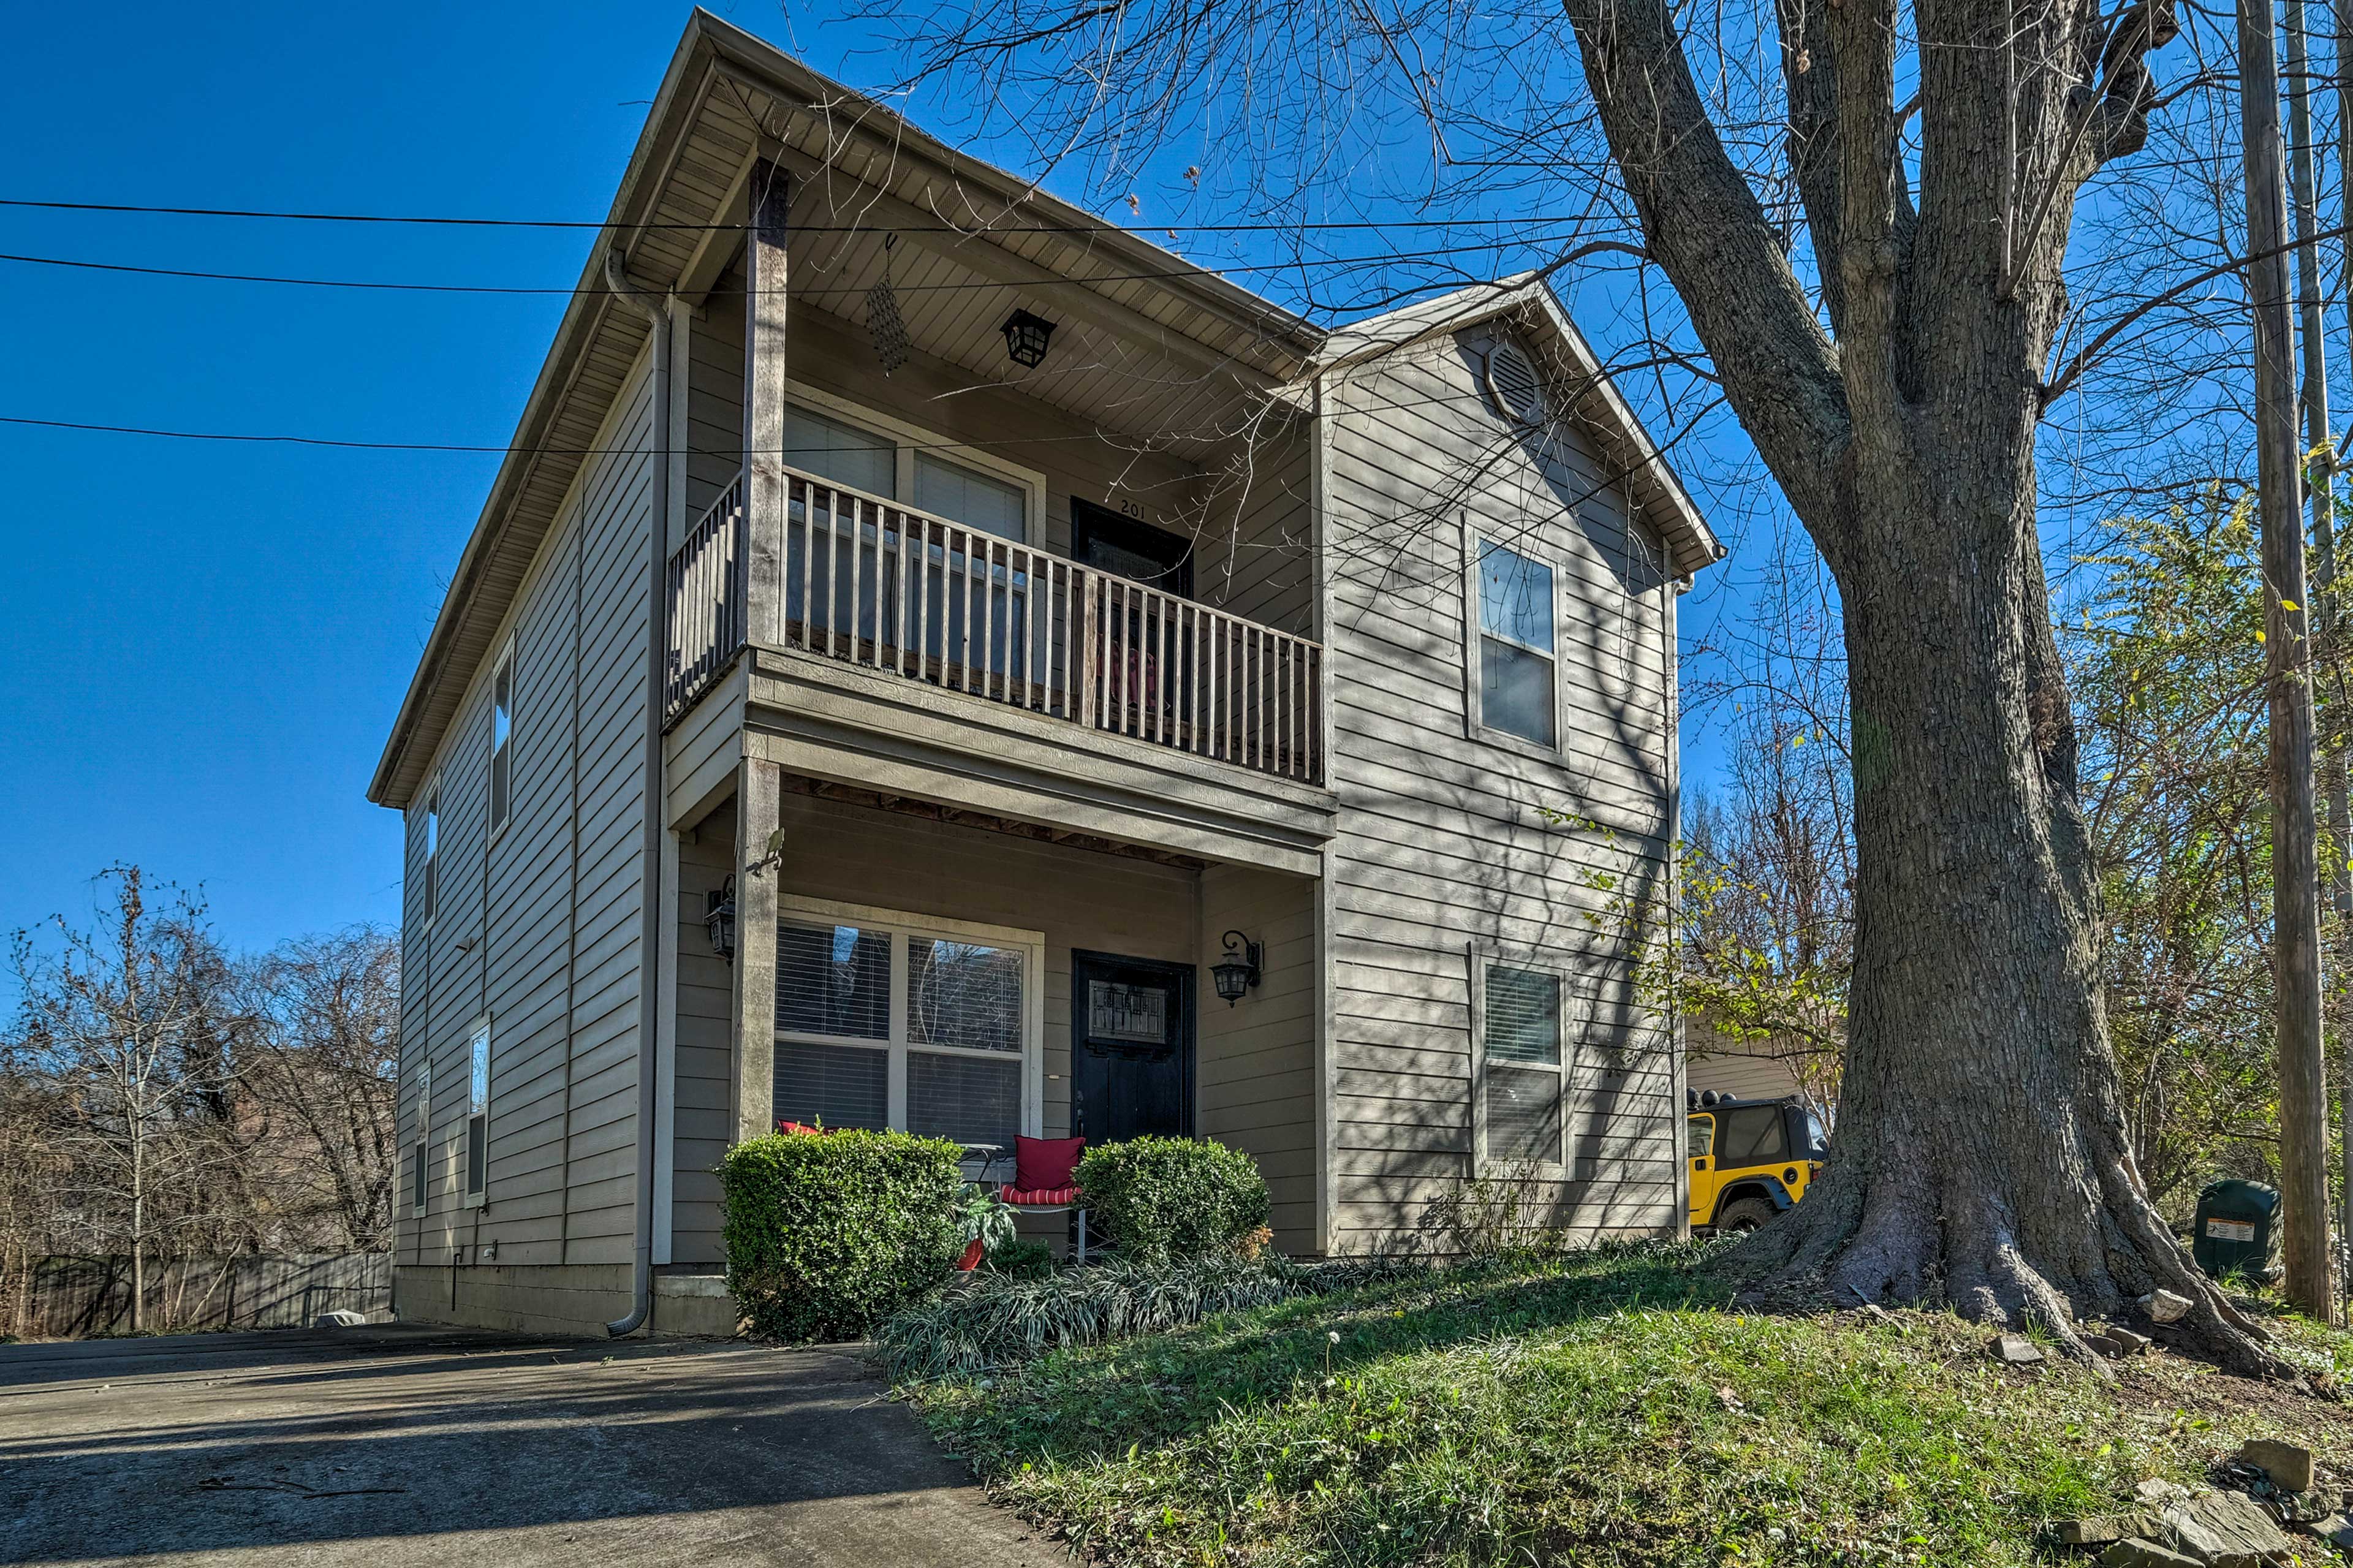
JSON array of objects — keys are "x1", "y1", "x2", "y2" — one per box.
[{"x1": 605, "y1": 245, "x2": 670, "y2": 1339}]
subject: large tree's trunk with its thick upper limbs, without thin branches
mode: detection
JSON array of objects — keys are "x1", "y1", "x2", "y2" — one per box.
[{"x1": 1565, "y1": 0, "x2": 2285, "y2": 1373}]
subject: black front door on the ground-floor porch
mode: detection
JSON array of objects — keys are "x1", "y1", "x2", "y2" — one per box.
[{"x1": 1070, "y1": 953, "x2": 1193, "y2": 1144}]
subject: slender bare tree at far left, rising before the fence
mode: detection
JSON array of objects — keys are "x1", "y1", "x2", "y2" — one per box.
[{"x1": 0, "y1": 866, "x2": 247, "y2": 1333}]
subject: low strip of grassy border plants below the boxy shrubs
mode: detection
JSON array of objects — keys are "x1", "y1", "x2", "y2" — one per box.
[{"x1": 875, "y1": 1252, "x2": 1417, "y2": 1380}]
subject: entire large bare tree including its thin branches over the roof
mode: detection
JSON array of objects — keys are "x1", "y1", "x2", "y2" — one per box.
[{"x1": 870, "y1": 0, "x2": 2302, "y2": 1375}]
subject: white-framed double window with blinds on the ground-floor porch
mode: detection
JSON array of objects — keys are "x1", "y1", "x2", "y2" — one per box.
[{"x1": 774, "y1": 909, "x2": 1042, "y2": 1149}]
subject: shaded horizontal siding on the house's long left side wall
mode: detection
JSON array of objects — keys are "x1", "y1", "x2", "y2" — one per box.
[{"x1": 400, "y1": 355, "x2": 652, "y2": 1267}]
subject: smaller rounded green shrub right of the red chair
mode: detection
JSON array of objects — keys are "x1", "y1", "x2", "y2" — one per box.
[{"x1": 1078, "y1": 1137, "x2": 1266, "y2": 1264}]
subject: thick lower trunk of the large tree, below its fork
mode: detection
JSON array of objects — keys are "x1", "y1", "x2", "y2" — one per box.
[{"x1": 1743, "y1": 442, "x2": 2271, "y2": 1370}]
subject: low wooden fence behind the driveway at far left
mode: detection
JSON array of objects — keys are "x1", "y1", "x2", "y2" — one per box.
[{"x1": 0, "y1": 1252, "x2": 393, "y2": 1339}]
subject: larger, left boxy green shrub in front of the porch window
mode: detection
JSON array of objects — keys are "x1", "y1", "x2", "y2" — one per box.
[{"x1": 720, "y1": 1132, "x2": 963, "y2": 1339}]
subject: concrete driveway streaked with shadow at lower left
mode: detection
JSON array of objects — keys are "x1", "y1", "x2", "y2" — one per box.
[{"x1": 0, "y1": 1325, "x2": 1070, "y2": 1568}]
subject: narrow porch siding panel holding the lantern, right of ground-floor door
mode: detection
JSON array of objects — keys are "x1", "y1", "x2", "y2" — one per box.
[{"x1": 1195, "y1": 866, "x2": 1317, "y2": 1255}]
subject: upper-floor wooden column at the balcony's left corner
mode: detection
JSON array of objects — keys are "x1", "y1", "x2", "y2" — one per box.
[{"x1": 743, "y1": 157, "x2": 790, "y2": 648}]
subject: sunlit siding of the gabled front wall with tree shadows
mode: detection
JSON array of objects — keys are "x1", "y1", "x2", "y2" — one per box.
[{"x1": 1325, "y1": 322, "x2": 1675, "y2": 1250}]
